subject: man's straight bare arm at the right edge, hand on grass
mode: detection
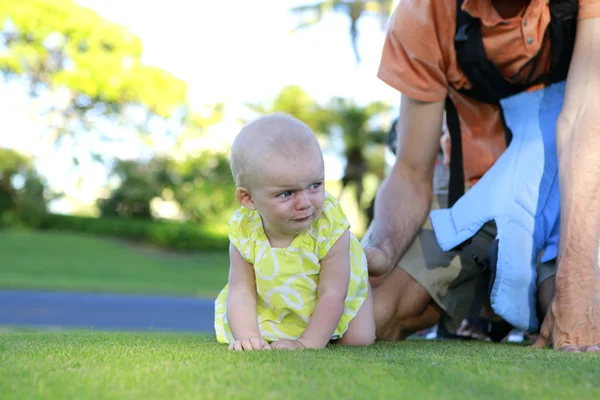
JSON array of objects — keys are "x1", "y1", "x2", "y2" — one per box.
[{"x1": 536, "y1": 18, "x2": 600, "y2": 351}]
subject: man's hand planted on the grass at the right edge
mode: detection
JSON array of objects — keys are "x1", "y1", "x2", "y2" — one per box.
[{"x1": 533, "y1": 265, "x2": 600, "y2": 352}]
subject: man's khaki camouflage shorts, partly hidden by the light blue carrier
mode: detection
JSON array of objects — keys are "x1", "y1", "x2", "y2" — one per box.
[{"x1": 398, "y1": 194, "x2": 556, "y2": 332}]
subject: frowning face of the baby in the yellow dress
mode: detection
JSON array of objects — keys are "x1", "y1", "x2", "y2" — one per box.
[{"x1": 252, "y1": 151, "x2": 325, "y2": 239}]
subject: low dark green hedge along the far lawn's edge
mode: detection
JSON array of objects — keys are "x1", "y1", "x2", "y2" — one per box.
[{"x1": 39, "y1": 214, "x2": 229, "y2": 251}]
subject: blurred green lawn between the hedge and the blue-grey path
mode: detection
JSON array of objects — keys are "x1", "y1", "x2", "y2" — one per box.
[{"x1": 0, "y1": 230, "x2": 229, "y2": 296}]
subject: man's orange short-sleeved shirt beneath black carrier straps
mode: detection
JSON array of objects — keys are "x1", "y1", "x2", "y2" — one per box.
[{"x1": 378, "y1": 0, "x2": 600, "y2": 183}]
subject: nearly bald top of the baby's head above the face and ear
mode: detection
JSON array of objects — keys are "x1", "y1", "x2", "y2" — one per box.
[{"x1": 231, "y1": 114, "x2": 322, "y2": 187}]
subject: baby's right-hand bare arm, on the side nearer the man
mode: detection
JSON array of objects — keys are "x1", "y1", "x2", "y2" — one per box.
[{"x1": 298, "y1": 230, "x2": 350, "y2": 348}]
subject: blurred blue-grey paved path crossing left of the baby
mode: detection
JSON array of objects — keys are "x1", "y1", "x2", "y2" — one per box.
[{"x1": 0, "y1": 290, "x2": 214, "y2": 333}]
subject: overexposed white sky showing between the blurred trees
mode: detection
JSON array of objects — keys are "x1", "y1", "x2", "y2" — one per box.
[{"x1": 0, "y1": 0, "x2": 400, "y2": 212}]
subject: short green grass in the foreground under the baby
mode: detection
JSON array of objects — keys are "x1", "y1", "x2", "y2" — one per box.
[{"x1": 0, "y1": 331, "x2": 600, "y2": 400}]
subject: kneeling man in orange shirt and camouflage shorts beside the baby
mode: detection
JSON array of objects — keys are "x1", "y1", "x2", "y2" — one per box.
[{"x1": 364, "y1": 0, "x2": 600, "y2": 352}]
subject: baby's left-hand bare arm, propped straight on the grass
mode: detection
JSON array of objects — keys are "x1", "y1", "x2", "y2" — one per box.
[{"x1": 227, "y1": 244, "x2": 270, "y2": 350}]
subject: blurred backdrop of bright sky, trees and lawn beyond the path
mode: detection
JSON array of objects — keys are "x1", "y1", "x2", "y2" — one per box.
[{"x1": 0, "y1": 0, "x2": 400, "y2": 328}]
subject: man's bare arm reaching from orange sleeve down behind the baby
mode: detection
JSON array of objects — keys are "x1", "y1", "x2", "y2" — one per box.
[{"x1": 363, "y1": 96, "x2": 444, "y2": 276}]
